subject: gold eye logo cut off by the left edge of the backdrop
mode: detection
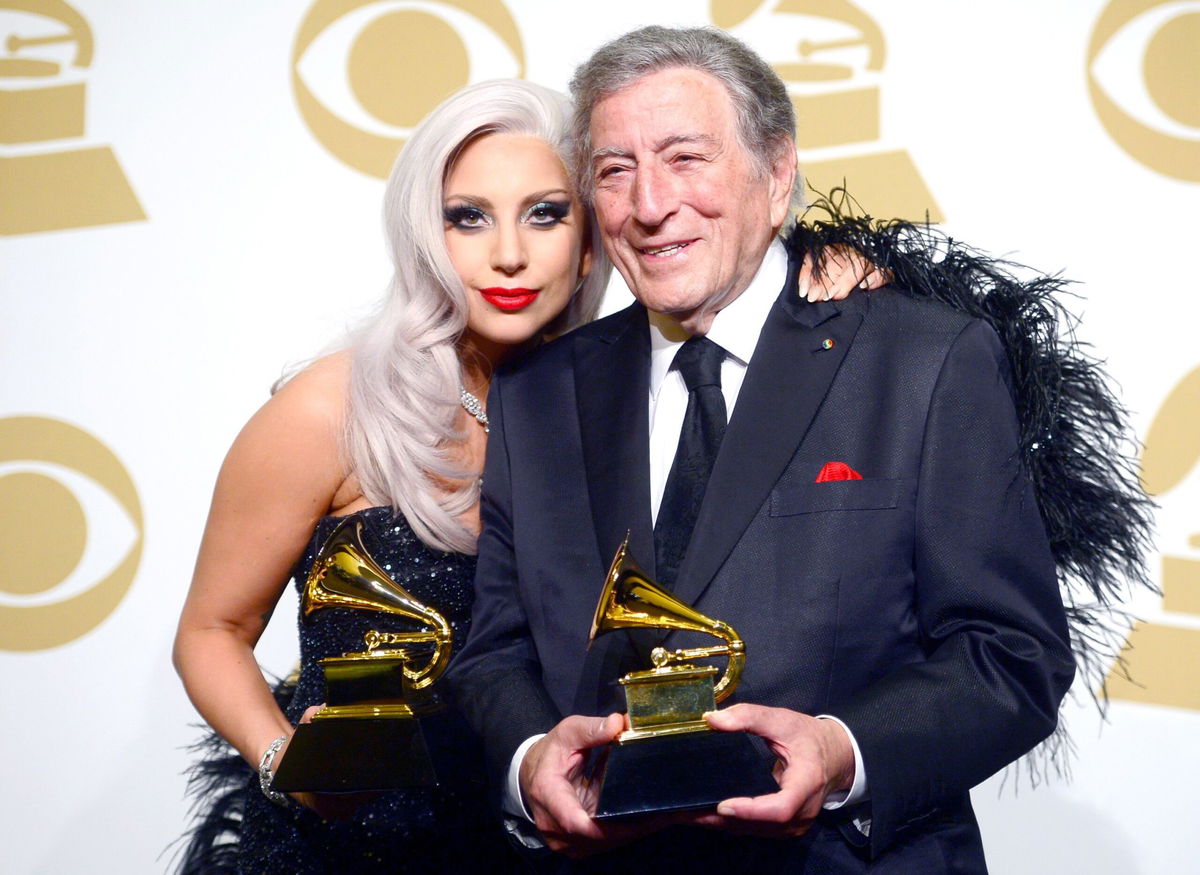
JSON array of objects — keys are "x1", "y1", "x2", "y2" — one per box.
[{"x1": 0, "y1": 416, "x2": 143, "y2": 651}]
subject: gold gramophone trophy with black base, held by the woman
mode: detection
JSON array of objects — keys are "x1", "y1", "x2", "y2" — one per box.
[{"x1": 272, "y1": 517, "x2": 452, "y2": 792}]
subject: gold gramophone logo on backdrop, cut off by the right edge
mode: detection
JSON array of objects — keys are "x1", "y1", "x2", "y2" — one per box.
[{"x1": 1108, "y1": 367, "x2": 1200, "y2": 711}]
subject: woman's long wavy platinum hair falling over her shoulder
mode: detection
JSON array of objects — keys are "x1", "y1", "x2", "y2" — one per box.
[{"x1": 344, "y1": 79, "x2": 610, "y2": 553}]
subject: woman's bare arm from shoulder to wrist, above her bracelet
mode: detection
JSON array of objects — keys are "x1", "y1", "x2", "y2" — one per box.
[{"x1": 174, "y1": 354, "x2": 353, "y2": 767}]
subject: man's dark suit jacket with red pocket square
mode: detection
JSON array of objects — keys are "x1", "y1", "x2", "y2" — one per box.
[{"x1": 450, "y1": 255, "x2": 1073, "y2": 871}]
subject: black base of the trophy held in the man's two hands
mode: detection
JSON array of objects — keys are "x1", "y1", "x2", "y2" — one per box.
[{"x1": 593, "y1": 730, "x2": 779, "y2": 820}]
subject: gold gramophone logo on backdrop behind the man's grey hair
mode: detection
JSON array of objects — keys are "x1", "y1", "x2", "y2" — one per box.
[{"x1": 709, "y1": 0, "x2": 944, "y2": 222}]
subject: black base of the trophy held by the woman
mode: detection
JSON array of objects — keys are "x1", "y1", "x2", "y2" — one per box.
[{"x1": 271, "y1": 718, "x2": 438, "y2": 793}]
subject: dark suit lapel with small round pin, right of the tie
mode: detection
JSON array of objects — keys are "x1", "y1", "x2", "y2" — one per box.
[{"x1": 676, "y1": 259, "x2": 865, "y2": 605}]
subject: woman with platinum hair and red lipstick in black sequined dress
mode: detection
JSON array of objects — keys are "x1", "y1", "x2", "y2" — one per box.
[{"x1": 174, "y1": 80, "x2": 857, "y2": 873}]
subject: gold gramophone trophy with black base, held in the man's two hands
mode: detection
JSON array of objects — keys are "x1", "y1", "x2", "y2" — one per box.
[{"x1": 588, "y1": 540, "x2": 779, "y2": 819}]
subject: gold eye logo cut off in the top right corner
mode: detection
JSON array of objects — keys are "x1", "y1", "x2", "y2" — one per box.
[{"x1": 1087, "y1": 0, "x2": 1200, "y2": 182}]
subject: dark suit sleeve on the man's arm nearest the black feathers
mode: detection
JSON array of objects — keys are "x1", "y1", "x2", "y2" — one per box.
[{"x1": 834, "y1": 322, "x2": 1074, "y2": 852}]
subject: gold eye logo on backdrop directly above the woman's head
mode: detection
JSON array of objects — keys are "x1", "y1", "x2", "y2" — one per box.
[{"x1": 292, "y1": 0, "x2": 524, "y2": 179}]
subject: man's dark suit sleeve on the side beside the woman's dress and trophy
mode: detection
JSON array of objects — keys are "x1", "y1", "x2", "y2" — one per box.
[{"x1": 446, "y1": 379, "x2": 560, "y2": 789}]
